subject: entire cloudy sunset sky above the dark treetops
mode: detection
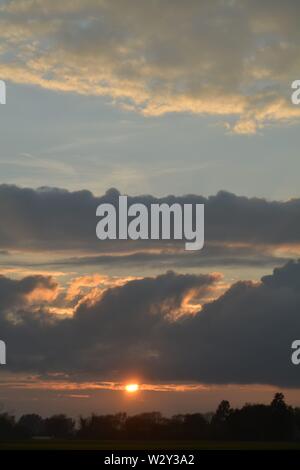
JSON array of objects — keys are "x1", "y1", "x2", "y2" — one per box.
[{"x1": 0, "y1": 0, "x2": 300, "y2": 415}]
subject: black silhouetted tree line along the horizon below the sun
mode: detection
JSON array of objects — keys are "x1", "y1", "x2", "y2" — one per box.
[{"x1": 0, "y1": 393, "x2": 300, "y2": 441}]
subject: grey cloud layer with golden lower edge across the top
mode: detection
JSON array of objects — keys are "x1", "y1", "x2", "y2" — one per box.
[{"x1": 0, "y1": 0, "x2": 300, "y2": 134}]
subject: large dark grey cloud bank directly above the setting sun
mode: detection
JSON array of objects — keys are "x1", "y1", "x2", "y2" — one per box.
[{"x1": 0, "y1": 262, "x2": 300, "y2": 387}]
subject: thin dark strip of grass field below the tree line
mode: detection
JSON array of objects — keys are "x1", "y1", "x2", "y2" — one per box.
[{"x1": 0, "y1": 440, "x2": 300, "y2": 450}]
